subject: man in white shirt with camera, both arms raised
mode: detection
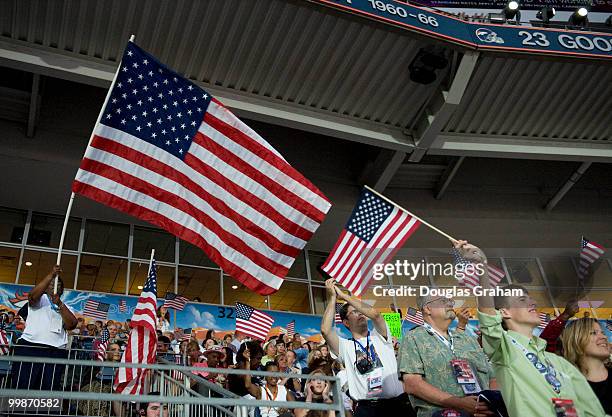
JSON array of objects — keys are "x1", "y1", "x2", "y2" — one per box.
[{"x1": 321, "y1": 279, "x2": 414, "y2": 417}]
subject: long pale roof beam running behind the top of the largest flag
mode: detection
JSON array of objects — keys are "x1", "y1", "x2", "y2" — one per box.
[{"x1": 0, "y1": 40, "x2": 414, "y2": 152}]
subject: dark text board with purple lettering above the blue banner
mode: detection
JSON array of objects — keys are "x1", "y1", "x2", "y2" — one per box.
[{"x1": 402, "y1": 0, "x2": 612, "y2": 13}]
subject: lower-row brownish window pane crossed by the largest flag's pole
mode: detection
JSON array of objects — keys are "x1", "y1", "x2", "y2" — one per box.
[{"x1": 19, "y1": 249, "x2": 77, "y2": 289}]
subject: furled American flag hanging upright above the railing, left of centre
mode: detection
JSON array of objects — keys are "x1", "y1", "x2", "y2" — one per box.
[{"x1": 113, "y1": 260, "x2": 157, "y2": 395}]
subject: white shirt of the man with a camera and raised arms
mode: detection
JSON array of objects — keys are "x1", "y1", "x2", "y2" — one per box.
[{"x1": 338, "y1": 325, "x2": 404, "y2": 400}]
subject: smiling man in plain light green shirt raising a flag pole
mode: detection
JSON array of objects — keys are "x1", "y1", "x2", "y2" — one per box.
[{"x1": 454, "y1": 237, "x2": 605, "y2": 417}]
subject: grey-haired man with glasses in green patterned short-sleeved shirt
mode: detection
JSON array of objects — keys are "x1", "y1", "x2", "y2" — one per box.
[{"x1": 398, "y1": 296, "x2": 494, "y2": 417}]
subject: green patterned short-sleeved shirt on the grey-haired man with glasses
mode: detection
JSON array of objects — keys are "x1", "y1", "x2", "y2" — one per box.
[{"x1": 397, "y1": 326, "x2": 494, "y2": 417}]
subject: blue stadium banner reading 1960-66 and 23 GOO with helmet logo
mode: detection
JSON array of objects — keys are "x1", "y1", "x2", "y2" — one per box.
[{"x1": 308, "y1": 0, "x2": 612, "y2": 59}]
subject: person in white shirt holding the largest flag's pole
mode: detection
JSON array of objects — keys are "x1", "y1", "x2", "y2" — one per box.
[{"x1": 11, "y1": 265, "x2": 78, "y2": 390}]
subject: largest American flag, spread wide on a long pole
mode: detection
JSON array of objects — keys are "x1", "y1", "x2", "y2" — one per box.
[{"x1": 72, "y1": 42, "x2": 330, "y2": 295}]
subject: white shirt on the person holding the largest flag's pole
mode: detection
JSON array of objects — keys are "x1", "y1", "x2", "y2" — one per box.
[{"x1": 21, "y1": 294, "x2": 72, "y2": 348}]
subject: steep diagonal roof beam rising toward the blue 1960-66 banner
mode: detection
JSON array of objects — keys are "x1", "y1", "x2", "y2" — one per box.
[{"x1": 408, "y1": 51, "x2": 479, "y2": 162}]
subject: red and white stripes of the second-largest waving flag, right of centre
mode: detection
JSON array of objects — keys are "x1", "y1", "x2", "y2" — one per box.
[{"x1": 322, "y1": 206, "x2": 421, "y2": 296}]
